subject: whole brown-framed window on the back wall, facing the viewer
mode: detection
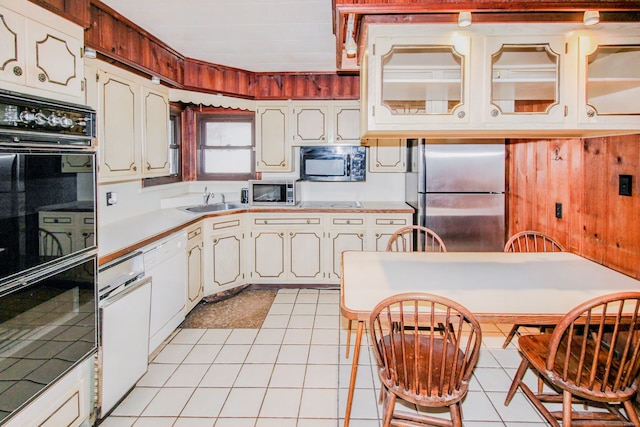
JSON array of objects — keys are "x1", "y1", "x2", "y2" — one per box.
[{"x1": 197, "y1": 114, "x2": 255, "y2": 181}]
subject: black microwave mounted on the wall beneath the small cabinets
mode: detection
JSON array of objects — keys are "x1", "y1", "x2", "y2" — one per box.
[{"x1": 300, "y1": 146, "x2": 367, "y2": 182}]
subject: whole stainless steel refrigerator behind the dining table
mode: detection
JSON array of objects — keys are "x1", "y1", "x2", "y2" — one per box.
[{"x1": 405, "y1": 139, "x2": 505, "y2": 252}]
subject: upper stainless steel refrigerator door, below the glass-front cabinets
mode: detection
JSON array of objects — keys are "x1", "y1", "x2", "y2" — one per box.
[{"x1": 418, "y1": 143, "x2": 505, "y2": 193}]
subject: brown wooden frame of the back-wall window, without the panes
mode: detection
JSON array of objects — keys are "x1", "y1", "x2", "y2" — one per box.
[{"x1": 195, "y1": 111, "x2": 257, "y2": 181}]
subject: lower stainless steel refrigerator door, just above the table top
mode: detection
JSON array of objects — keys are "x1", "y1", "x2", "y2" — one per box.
[{"x1": 420, "y1": 194, "x2": 505, "y2": 252}]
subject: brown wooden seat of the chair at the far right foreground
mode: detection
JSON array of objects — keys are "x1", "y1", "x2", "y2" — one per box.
[{"x1": 518, "y1": 334, "x2": 636, "y2": 402}]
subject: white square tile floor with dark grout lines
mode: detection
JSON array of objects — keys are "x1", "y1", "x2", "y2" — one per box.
[{"x1": 101, "y1": 289, "x2": 547, "y2": 427}]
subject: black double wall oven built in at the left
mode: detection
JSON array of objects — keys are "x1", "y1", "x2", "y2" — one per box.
[{"x1": 0, "y1": 91, "x2": 97, "y2": 424}]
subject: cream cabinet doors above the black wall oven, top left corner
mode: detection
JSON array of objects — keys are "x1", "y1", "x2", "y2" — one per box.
[{"x1": 0, "y1": 0, "x2": 84, "y2": 103}]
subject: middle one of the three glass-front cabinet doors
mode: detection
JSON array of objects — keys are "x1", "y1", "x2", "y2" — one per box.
[{"x1": 484, "y1": 37, "x2": 567, "y2": 123}]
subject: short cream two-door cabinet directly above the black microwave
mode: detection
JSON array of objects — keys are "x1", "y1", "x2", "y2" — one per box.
[{"x1": 291, "y1": 101, "x2": 360, "y2": 145}]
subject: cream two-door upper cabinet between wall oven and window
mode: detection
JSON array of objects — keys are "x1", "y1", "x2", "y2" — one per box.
[{"x1": 87, "y1": 61, "x2": 169, "y2": 183}]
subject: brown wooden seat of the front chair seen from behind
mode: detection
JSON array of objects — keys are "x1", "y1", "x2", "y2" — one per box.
[{"x1": 380, "y1": 334, "x2": 468, "y2": 406}]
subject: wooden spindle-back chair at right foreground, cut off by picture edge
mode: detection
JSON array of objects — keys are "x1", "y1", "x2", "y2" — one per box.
[{"x1": 505, "y1": 292, "x2": 640, "y2": 427}]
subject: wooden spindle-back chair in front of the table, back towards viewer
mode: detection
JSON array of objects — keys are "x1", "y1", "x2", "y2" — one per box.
[{"x1": 369, "y1": 293, "x2": 482, "y2": 427}]
